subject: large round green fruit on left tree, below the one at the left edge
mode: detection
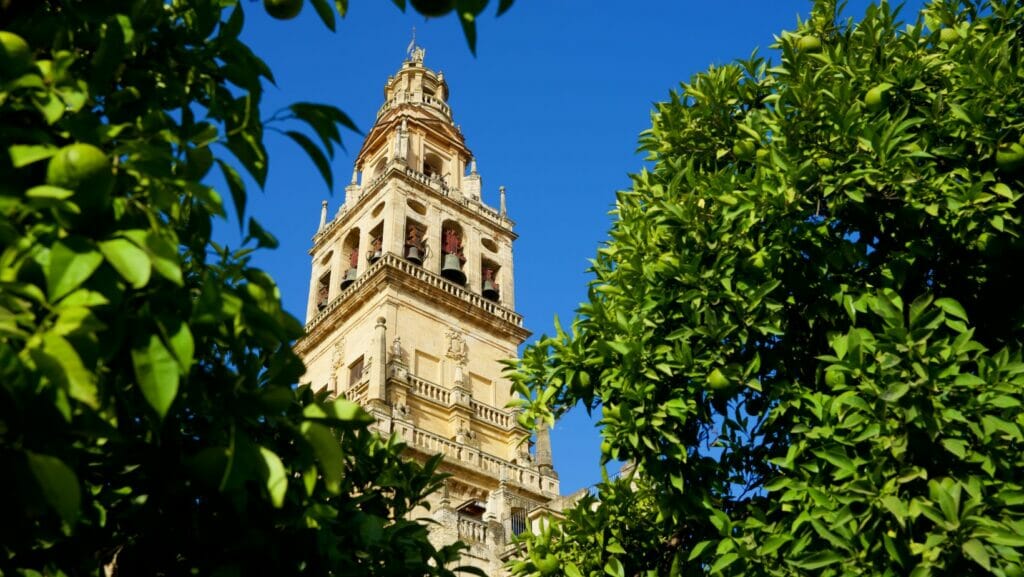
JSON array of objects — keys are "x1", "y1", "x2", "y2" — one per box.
[{"x1": 46, "y1": 142, "x2": 114, "y2": 208}]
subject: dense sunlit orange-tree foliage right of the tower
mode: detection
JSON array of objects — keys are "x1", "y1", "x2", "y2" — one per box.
[{"x1": 513, "y1": 0, "x2": 1024, "y2": 577}]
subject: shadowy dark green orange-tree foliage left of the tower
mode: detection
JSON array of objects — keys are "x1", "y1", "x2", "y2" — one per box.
[{"x1": 0, "y1": 0, "x2": 508, "y2": 576}]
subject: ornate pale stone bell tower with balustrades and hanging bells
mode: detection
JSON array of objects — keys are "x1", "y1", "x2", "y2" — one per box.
[{"x1": 296, "y1": 45, "x2": 560, "y2": 575}]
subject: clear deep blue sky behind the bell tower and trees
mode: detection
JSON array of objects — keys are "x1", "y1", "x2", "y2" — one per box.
[{"x1": 230, "y1": 0, "x2": 921, "y2": 493}]
